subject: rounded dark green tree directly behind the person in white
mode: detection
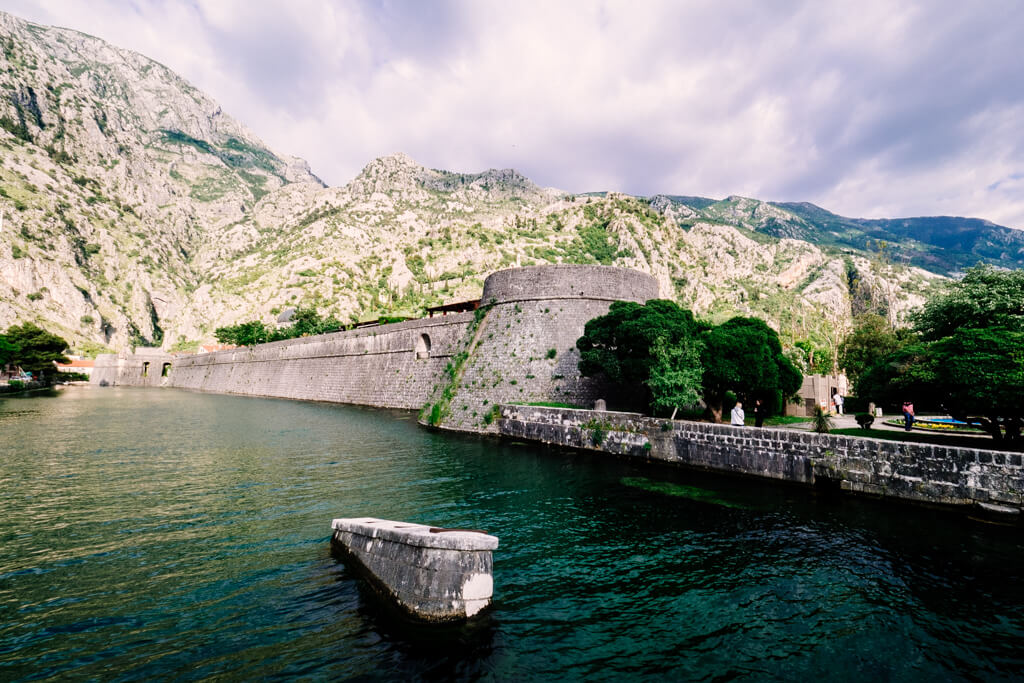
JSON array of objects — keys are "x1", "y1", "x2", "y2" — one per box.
[{"x1": 701, "y1": 316, "x2": 803, "y2": 421}]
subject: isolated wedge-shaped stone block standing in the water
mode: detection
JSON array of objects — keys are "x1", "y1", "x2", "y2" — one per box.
[{"x1": 331, "y1": 517, "x2": 498, "y2": 622}]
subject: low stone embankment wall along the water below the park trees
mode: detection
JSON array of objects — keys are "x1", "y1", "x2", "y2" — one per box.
[{"x1": 497, "y1": 405, "x2": 1024, "y2": 516}]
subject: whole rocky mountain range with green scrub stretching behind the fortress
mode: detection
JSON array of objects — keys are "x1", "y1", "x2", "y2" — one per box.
[{"x1": 0, "y1": 13, "x2": 1024, "y2": 374}]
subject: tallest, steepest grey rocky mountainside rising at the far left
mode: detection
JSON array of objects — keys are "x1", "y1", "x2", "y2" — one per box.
[{"x1": 0, "y1": 13, "x2": 323, "y2": 347}]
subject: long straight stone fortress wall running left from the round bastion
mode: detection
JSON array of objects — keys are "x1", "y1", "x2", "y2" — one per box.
[{"x1": 92, "y1": 313, "x2": 473, "y2": 409}]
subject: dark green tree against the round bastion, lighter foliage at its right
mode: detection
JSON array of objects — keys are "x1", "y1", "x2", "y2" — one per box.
[{"x1": 577, "y1": 299, "x2": 707, "y2": 408}]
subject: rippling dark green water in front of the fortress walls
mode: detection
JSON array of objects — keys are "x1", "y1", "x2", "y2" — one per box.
[{"x1": 0, "y1": 387, "x2": 1024, "y2": 681}]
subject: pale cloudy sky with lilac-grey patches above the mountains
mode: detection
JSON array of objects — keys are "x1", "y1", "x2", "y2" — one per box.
[{"x1": 6, "y1": 0, "x2": 1024, "y2": 228}]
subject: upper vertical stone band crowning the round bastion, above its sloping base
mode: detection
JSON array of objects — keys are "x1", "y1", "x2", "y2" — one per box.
[{"x1": 480, "y1": 265, "x2": 658, "y2": 305}]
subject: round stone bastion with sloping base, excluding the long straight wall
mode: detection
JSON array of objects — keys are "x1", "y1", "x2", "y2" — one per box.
[{"x1": 425, "y1": 265, "x2": 658, "y2": 432}]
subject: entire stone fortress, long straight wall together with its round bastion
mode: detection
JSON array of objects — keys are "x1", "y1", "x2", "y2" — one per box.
[{"x1": 92, "y1": 265, "x2": 658, "y2": 423}]
